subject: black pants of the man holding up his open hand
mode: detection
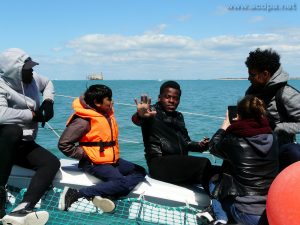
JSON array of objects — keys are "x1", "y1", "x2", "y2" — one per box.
[{"x1": 147, "y1": 155, "x2": 211, "y2": 186}]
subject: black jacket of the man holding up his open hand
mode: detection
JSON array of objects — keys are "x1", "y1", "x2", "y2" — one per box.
[{"x1": 133, "y1": 103, "x2": 205, "y2": 161}]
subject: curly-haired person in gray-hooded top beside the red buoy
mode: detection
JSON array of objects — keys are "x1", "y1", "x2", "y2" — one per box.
[{"x1": 245, "y1": 48, "x2": 300, "y2": 170}]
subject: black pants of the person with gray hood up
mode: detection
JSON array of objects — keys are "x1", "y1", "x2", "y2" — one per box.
[{"x1": 0, "y1": 124, "x2": 60, "y2": 207}]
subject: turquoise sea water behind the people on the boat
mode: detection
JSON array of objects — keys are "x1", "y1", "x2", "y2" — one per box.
[{"x1": 37, "y1": 80, "x2": 300, "y2": 169}]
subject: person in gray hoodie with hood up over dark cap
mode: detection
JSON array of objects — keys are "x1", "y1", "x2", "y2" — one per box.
[{"x1": 0, "y1": 48, "x2": 60, "y2": 225}]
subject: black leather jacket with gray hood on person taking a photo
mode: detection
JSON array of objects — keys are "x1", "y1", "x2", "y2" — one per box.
[{"x1": 209, "y1": 129, "x2": 278, "y2": 199}]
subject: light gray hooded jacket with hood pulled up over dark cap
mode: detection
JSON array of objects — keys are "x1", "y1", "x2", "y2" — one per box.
[{"x1": 0, "y1": 48, "x2": 54, "y2": 141}]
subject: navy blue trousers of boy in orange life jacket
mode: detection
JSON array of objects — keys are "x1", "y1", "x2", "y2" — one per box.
[{"x1": 79, "y1": 159, "x2": 146, "y2": 198}]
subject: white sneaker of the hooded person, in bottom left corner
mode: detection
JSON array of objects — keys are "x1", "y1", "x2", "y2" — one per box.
[{"x1": 2, "y1": 209, "x2": 49, "y2": 225}]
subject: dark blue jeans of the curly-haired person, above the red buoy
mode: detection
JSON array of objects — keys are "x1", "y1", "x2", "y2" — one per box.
[{"x1": 279, "y1": 143, "x2": 300, "y2": 171}]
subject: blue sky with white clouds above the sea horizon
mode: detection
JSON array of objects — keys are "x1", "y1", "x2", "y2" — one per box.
[{"x1": 0, "y1": 0, "x2": 300, "y2": 80}]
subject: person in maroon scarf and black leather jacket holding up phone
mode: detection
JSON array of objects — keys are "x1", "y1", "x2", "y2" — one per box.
[{"x1": 209, "y1": 95, "x2": 278, "y2": 225}]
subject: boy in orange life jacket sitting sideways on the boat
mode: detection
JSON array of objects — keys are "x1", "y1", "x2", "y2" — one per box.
[{"x1": 58, "y1": 84, "x2": 146, "y2": 212}]
